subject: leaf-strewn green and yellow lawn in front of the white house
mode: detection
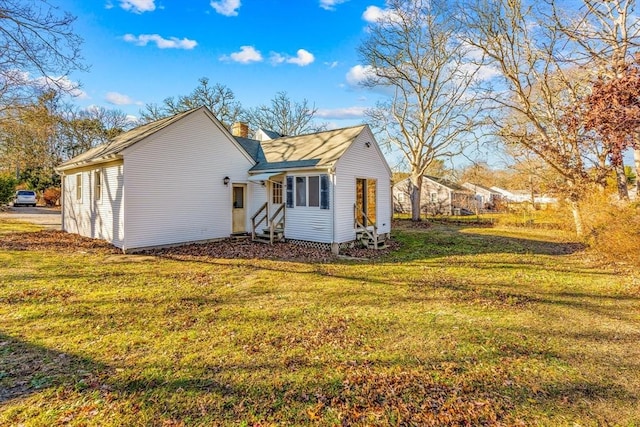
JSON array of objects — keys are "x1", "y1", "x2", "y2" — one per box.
[{"x1": 0, "y1": 222, "x2": 640, "y2": 426}]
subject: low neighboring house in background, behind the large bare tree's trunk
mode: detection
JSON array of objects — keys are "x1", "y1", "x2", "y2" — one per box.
[{"x1": 393, "y1": 175, "x2": 473, "y2": 215}]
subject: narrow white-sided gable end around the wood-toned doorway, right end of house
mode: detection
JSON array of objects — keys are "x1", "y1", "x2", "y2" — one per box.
[{"x1": 333, "y1": 129, "x2": 392, "y2": 243}]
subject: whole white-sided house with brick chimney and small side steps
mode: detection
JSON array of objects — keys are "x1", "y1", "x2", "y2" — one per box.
[{"x1": 56, "y1": 107, "x2": 391, "y2": 251}]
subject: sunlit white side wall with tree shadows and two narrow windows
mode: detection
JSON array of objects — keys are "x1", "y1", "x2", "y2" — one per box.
[{"x1": 63, "y1": 164, "x2": 124, "y2": 248}]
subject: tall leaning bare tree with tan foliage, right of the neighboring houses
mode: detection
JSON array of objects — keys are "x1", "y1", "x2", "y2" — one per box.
[{"x1": 461, "y1": 0, "x2": 610, "y2": 235}]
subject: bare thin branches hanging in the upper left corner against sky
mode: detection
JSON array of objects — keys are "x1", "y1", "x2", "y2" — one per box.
[{"x1": 0, "y1": 0, "x2": 85, "y2": 108}]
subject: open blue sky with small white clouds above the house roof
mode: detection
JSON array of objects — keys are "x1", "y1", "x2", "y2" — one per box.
[{"x1": 55, "y1": 0, "x2": 384, "y2": 127}]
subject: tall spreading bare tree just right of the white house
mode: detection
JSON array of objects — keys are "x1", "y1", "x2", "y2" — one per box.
[{"x1": 359, "y1": 0, "x2": 479, "y2": 221}]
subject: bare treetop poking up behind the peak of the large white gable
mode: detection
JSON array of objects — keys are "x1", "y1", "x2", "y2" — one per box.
[{"x1": 140, "y1": 77, "x2": 242, "y2": 128}]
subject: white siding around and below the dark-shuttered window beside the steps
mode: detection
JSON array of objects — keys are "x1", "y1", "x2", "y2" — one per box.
[{"x1": 283, "y1": 171, "x2": 334, "y2": 243}]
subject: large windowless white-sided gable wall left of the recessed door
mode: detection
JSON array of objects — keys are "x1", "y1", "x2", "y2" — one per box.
[{"x1": 123, "y1": 111, "x2": 255, "y2": 249}]
